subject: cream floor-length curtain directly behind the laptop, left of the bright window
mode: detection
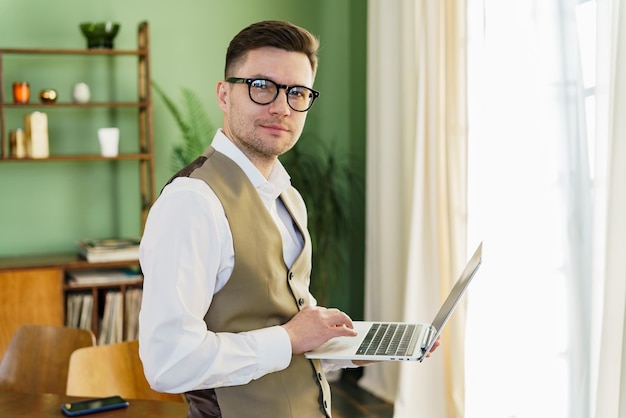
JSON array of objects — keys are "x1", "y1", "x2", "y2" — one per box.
[{"x1": 360, "y1": 0, "x2": 467, "y2": 418}]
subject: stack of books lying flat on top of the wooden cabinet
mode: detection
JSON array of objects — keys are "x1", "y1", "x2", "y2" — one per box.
[{"x1": 78, "y1": 238, "x2": 140, "y2": 263}]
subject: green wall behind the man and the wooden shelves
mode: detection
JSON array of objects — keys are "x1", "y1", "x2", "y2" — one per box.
[{"x1": 0, "y1": 0, "x2": 367, "y2": 317}]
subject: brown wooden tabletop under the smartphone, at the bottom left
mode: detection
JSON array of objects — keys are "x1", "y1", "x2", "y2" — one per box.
[{"x1": 0, "y1": 392, "x2": 187, "y2": 418}]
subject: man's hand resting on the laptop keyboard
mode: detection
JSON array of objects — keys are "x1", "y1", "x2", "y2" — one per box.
[{"x1": 283, "y1": 306, "x2": 357, "y2": 354}]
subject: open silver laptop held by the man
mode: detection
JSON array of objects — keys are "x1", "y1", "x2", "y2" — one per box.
[{"x1": 304, "y1": 242, "x2": 483, "y2": 362}]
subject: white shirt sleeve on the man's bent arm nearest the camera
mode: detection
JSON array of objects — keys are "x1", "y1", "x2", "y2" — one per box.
[{"x1": 139, "y1": 178, "x2": 292, "y2": 393}]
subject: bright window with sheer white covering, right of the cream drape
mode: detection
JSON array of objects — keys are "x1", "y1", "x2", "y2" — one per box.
[{"x1": 466, "y1": 0, "x2": 595, "y2": 418}]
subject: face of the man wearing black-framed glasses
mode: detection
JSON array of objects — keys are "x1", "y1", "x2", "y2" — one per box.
[{"x1": 217, "y1": 47, "x2": 314, "y2": 166}]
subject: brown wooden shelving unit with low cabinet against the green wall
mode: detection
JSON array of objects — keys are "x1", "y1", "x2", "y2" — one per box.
[{"x1": 0, "y1": 22, "x2": 155, "y2": 357}]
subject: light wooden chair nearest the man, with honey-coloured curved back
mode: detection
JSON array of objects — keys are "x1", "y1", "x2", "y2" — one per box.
[{"x1": 67, "y1": 340, "x2": 185, "y2": 402}]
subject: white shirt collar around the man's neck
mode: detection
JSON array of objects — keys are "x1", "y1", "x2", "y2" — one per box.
[{"x1": 211, "y1": 129, "x2": 291, "y2": 199}]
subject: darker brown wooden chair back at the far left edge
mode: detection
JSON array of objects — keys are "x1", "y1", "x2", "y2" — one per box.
[{"x1": 0, "y1": 325, "x2": 96, "y2": 394}]
